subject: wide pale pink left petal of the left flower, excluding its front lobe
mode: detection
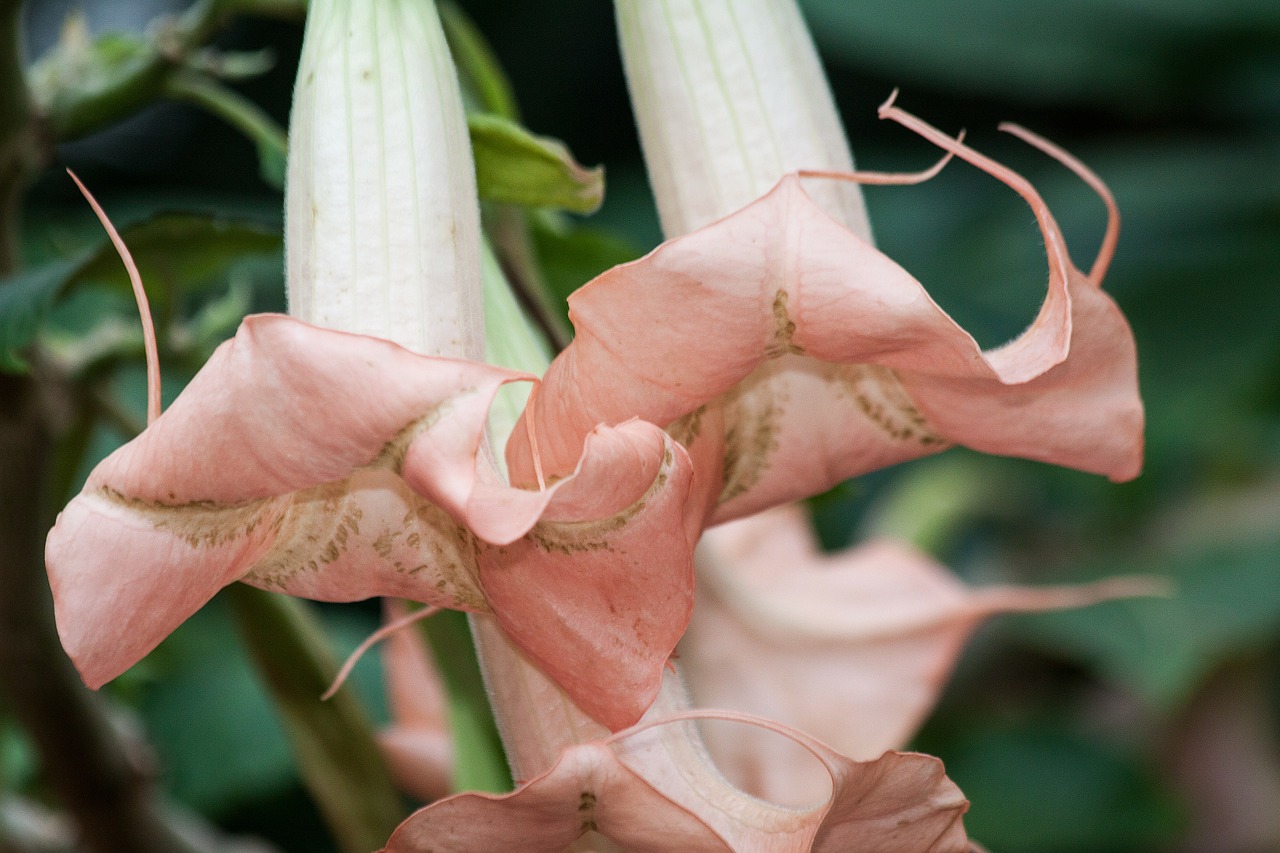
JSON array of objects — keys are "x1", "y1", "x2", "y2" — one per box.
[{"x1": 46, "y1": 315, "x2": 509, "y2": 686}]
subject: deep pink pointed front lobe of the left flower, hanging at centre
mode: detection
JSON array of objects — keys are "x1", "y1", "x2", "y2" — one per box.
[{"x1": 480, "y1": 421, "x2": 700, "y2": 730}]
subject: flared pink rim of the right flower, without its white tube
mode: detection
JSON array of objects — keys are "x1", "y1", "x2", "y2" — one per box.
[{"x1": 508, "y1": 108, "x2": 1143, "y2": 521}]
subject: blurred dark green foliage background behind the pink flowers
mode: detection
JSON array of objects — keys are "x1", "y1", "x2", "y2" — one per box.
[{"x1": 0, "y1": 0, "x2": 1280, "y2": 853}]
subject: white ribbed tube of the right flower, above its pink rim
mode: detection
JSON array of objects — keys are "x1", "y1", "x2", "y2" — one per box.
[{"x1": 614, "y1": 0, "x2": 870, "y2": 240}]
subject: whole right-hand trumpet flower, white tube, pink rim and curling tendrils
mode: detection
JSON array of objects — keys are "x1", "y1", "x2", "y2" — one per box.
[{"x1": 509, "y1": 0, "x2": 1143, "y2": 521}]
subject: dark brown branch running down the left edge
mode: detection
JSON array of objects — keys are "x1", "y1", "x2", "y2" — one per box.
[{"x1": 0, "y1": 0, "x2": 254, "y2": 853}]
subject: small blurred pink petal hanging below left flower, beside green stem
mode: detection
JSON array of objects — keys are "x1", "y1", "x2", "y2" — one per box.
[{"x1": 378, "y1": 598, "x2": 453, "y2": 803}]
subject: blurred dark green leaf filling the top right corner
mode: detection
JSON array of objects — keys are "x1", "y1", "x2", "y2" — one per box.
[{"x1": 803, "y1": 0, "x2": 1280, "y2": 109}]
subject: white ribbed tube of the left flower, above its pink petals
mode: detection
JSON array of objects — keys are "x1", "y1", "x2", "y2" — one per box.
[{"x1": 285, "y1": 0, "x2": 484, "y2": 360}]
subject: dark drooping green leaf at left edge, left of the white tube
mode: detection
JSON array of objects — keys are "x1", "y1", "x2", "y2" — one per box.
[{"x1": 0, "y1": 213, "x2": 280, "y2": 371}]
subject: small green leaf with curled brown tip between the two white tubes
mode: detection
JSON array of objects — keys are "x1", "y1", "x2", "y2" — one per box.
[{"x1": 467, "y1": 113, "x2": 604, "y2": 213}]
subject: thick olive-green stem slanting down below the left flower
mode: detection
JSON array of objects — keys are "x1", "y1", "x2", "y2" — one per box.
[{"x1": 227, "y1": 584, "x2": 404, "y2": 853}]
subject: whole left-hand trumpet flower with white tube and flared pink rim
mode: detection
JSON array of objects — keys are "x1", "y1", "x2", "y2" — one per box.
[{"x1": 46, "y1": 0, "x2": 692, "y2": 727}]
